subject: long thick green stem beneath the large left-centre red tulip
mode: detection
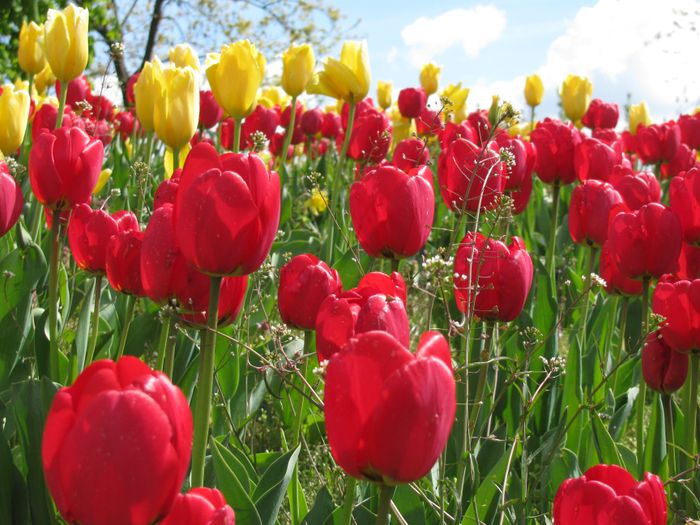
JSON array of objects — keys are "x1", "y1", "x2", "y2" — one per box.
[{"x1": 191, "y1": 275, "x2": 221, "y2": 488}]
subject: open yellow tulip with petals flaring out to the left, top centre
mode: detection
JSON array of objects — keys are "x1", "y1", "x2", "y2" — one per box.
[{"x1": 307, "y1": 40, "x2": 371, "y2": 103}]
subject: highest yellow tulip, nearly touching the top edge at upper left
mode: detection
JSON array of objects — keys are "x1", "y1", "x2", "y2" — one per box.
[{"x1": 44, "y1": 4, "x2": 89, "y2": 83}]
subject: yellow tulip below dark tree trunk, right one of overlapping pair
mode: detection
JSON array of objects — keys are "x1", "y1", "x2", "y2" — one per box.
[{"x1": 153, "y1": 67, "x2": 199, "y2": 149}]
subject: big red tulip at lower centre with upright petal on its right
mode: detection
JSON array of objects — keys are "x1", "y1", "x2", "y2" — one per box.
[{"x1": 323, "y1": 331, "x2": 456, "y2": 484}]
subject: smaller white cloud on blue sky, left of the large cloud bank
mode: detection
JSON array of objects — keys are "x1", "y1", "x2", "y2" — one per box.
[{"x1": 401, "y1": 4, "x2": 506, "y2": 66}]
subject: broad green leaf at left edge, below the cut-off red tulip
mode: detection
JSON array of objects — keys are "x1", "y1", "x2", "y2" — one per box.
[{"x1": 0, "y1": 244, "x2": 46, "y2": 319}]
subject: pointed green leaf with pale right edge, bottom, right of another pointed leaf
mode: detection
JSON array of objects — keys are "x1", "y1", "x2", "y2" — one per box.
[{"x1": 253, "y1": 447, "x2": 301, "y2": 525}]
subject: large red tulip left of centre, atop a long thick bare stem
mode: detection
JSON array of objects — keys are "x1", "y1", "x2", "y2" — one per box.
[{"x1": 175, "y1": 143, "x2": 280, "y2": 275}]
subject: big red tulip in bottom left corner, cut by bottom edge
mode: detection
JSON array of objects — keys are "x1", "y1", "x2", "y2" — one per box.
[{"x1": 41, "y1": 356, "x2": 192, "y2": 525}]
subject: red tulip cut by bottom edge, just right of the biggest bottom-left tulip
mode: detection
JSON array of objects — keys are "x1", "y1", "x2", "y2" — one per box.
[{"x1": 160, "y1": 487, "x2": 236, "y2": 525}]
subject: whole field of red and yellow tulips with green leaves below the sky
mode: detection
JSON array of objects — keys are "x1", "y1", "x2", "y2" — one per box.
[{"x1": 0, "y1": 4, "x2": 700, "y2": 525}]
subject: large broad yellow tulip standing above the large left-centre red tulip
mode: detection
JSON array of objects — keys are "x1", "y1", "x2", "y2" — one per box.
[{"x1": 207, "y1": 40, "x2": 265, "y2": 120}]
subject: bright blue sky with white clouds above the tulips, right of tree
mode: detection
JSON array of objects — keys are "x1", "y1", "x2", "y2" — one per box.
[{"x1": 314, "y1": 0, "x2": 700, "y2": 118}]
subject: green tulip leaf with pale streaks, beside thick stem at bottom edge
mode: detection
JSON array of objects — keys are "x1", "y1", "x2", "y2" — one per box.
[{"x1": 211, "y1": 439, "x2": 263, "y2": 525}]
